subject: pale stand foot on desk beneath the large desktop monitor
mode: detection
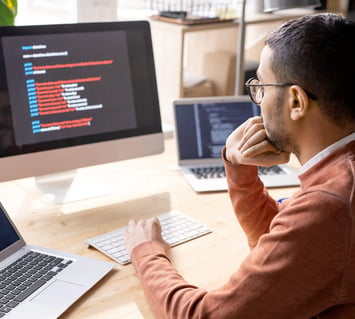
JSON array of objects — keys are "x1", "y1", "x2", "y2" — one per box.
[{"x1": 35, "y1": 170, "x2": 111, "y2": 204}]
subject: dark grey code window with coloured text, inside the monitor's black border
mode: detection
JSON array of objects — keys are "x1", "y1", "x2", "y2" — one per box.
[{"x1": 3, "y1": 31, "x2": 136, "y2": 145}]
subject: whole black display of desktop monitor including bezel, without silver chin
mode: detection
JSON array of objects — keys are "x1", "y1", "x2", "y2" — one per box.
[{"x1": 0, "y1": 23, "x2": 161, "y2": 156}]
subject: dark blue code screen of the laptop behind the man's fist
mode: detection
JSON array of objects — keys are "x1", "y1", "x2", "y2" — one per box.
[{"x1": 175, "y1": 101, "x2": 260, "y2": 160}]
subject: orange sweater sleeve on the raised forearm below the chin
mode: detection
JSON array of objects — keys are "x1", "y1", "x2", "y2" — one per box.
[{"x1": 222, "y1": 149, "x2": 278, "y2": 248}]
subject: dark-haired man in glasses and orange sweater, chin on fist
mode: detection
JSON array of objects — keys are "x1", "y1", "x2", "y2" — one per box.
[{"x1": 125, "y1": 14, "x2": 355, "y2": 319}]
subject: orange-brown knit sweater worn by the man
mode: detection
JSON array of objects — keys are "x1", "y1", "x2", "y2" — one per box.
[{"x1": 131, "y1": 141, "x2": 355, "y2": 319}]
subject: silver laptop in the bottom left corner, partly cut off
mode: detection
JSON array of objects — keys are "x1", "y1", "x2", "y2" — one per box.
[{"x1": 0, "y1": 204, "x2": 114, "y2": 319}]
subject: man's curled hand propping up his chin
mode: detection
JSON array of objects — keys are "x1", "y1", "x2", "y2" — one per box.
[{"x1": 226, "y1": 116, "x2": 290, "y2": 166}]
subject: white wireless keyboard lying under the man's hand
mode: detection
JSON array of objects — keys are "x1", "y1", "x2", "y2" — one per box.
[{"x1": 85, "y1": 210, "x2": 212, "y2": 265}]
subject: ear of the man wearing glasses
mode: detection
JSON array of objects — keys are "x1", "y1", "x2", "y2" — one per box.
[{"x1": 289, "y1": 85, "x2": 309, "y2": 121}]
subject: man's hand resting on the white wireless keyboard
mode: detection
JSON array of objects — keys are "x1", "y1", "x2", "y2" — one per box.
[{"x1": 122, "y1": 218, "x2": 169, "y2": 255}]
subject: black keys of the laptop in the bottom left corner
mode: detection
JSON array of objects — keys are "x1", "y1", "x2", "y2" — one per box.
[{"x1": 0, "y1": 251, "x2": 73, "y2": 318}]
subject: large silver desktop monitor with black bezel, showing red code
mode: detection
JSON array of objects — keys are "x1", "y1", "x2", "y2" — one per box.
[{"x1": 0, "y1": 21, "x2": 164, "y2": 202}]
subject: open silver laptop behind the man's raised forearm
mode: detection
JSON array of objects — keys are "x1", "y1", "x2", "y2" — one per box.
[{"x1": 173, "y1": 96, "x2": 299, "y2": 192}]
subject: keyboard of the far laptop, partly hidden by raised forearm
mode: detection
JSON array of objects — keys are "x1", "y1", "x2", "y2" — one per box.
[{"x1": 191, "y1": 165, "x2": 286, "y2": 179}]
